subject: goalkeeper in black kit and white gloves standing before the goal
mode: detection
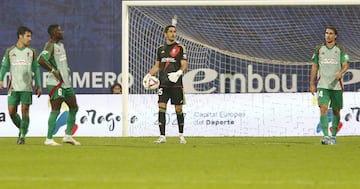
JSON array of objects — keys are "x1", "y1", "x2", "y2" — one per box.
[{"x1": 144, "y1": 25, "x2": 187, "y2": 144}]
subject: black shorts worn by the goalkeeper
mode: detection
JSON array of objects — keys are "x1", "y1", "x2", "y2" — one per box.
[{"x1": 158, "y1": 87, "x2": 185, "y2": 105}]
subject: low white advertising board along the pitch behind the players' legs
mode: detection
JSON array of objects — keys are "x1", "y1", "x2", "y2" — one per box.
[{"x1": 0, "y1": 92, "x2": 360, "y2": 137}]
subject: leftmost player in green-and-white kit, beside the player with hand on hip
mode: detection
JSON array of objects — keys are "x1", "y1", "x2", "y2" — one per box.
[{"x1": 0, "y1": 26, "x2": 42, "y2": 144}]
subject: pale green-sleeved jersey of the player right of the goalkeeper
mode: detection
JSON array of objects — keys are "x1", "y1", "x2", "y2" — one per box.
[{"x1": 312, "y1": 44, "x2": 349, "y2": 90}]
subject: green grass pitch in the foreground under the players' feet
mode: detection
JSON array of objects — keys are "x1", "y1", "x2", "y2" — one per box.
[{"x1": 0, "y1": 136, "x2": 360, "y2": 189}]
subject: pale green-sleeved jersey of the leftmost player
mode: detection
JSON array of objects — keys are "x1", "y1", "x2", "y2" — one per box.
[{"x1": 0, "y1": 45, "x2": 41, "y2": 91}]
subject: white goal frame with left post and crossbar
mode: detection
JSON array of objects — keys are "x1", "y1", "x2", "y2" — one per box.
[{"x1": 121, "y1": 0, "x2": 360, "y2": 137}]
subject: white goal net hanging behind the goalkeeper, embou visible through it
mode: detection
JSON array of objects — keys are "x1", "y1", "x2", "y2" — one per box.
[{"x1": 123, "y1": 0, "x2": 360, "y2": 94}]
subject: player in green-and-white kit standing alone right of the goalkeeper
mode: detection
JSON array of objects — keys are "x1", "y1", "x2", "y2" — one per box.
[{"x1": 310, "y1": 26, "x2": 349, "y2": 145}]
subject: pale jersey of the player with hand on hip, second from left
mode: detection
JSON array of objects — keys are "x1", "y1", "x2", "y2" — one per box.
[{"x1": 39, "y1": 40, "x2": 72, "y2": 88}]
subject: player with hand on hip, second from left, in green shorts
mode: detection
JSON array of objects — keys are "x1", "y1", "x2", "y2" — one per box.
[{"x1": 38, "y1": 24, "x2": 80, "y2": 146}]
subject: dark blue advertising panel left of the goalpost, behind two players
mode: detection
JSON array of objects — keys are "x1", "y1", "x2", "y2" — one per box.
[{"x1": 0, "y1": 0, "x2": 121, "y2": 94}]
